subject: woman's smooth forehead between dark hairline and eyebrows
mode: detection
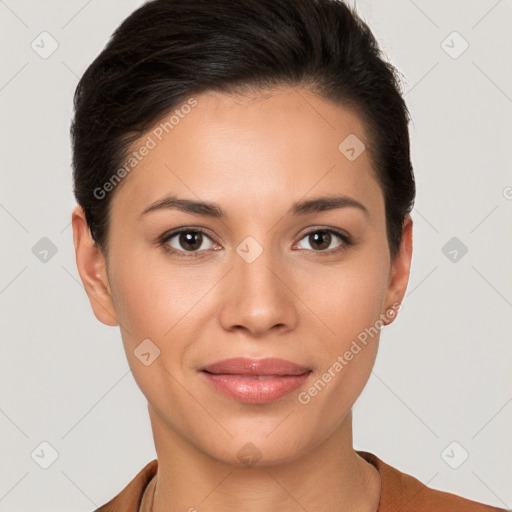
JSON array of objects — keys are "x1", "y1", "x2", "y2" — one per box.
[{"x1": 112, "y1": 87, "x2": 382, "y2": 222}]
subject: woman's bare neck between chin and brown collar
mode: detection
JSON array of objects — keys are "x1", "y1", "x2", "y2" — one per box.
[{"x1": 144, "y1": 405, "x2": 381, "y2": 512}]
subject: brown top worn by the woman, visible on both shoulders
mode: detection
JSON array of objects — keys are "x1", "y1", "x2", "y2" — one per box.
[{"x1": 94, "y1": 450, "x2": 506, "y2": 512}]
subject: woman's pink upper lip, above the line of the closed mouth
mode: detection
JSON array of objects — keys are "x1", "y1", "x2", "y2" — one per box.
[{"x1": 201, "y1": 357, "x2": 311, "y2": 375}]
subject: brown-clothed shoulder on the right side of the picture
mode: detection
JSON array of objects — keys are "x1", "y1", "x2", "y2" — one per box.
[{"x1": 356, "y1": 450, "x2": 506, "y2": 512}]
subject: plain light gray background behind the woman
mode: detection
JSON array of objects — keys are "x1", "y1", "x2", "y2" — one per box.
[{"x1": 0, "y1": 0, "x2": 512, "y2": 512}]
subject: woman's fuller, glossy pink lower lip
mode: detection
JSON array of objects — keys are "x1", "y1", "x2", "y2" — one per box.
[{"x1": 201, "y1": 371, "x2": 311, "y2": 404}]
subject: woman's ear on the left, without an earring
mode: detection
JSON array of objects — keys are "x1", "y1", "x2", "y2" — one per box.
[{"x1": 71, "y1": 206, "x2": 118, "y2": 326}]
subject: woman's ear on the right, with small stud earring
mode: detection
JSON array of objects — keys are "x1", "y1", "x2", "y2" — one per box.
[{"x1": 382, "y1": 215, "x2": 412, "y2": 325}]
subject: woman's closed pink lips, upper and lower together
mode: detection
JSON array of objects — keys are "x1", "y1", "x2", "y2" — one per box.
[{"x1": 201, "y1": 358, "x2": 311, "y2": 404}]
